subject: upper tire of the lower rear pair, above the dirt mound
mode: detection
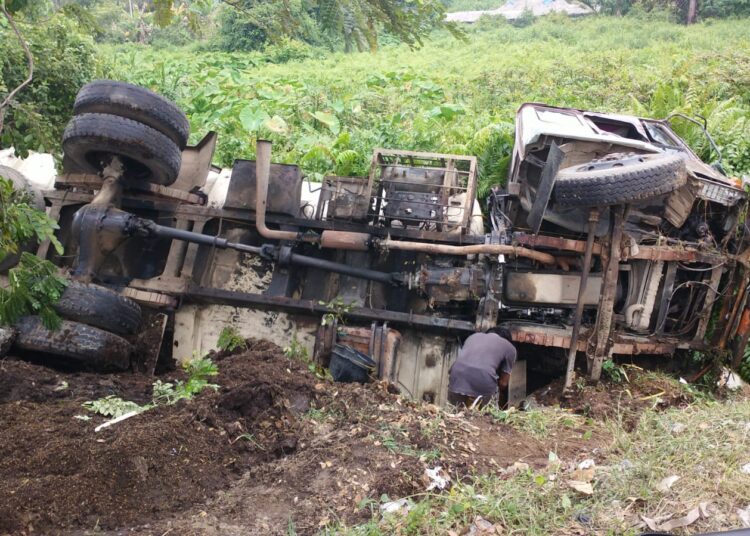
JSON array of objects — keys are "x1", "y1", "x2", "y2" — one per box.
[{"x1": 54, "y1": 281, "x2": 141, "y2": 335}]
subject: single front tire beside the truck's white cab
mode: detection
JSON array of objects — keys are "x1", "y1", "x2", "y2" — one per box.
[{"x1": 554, "y1": 153, "x2": 687, "y2": 207}]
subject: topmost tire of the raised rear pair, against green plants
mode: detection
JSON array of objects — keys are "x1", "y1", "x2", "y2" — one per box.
[{"x1": 73, "y1": 80, "x2": 190, "y2": 150}]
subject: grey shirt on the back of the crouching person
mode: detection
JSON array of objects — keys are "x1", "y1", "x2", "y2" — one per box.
[{"x1": 448, "y1": 333, "x2": 516, "y2": 396}]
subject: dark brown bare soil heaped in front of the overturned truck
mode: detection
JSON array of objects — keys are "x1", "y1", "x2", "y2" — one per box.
[{"x1": 0, "y1": 341, "x2": 600, "y2": 535}]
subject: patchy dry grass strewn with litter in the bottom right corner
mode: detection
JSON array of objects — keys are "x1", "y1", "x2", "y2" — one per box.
[{"x1": 327, "y1": 400, "x2": 750, "y2": 536}]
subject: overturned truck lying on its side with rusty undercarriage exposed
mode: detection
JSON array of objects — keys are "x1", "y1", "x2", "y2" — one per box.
[{"x1": 7, "y1": 81, "x2": 750, "y2": 403}]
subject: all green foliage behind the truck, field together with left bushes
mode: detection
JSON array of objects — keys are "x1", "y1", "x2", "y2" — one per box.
[{"x1": 0, "y1": 0, "x2": 750, "y2": 199}]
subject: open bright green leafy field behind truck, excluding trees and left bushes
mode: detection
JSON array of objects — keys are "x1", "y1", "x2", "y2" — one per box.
[{"x1": 106, "y1": 16, "x2": 750, "y2": 198}]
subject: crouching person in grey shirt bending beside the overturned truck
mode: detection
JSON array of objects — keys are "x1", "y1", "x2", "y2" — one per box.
[{"x1": 448, "y1": 328, "x2": 516, "y2": 409}]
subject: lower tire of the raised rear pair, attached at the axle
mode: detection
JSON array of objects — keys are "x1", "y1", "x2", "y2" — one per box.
[{"x1": 63, "y1": 114, "x2": 182, "y2": 186}]
